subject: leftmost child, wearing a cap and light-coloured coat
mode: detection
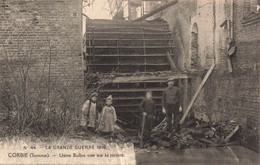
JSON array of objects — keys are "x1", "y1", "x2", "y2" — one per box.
[{"x1": 80, "y1": 93, "x2": 102, "y2": 131}]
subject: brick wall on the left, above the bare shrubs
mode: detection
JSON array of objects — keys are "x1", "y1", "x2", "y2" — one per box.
[{"x1": 0, "y1": 0, "x2": 83, "y2": 94}]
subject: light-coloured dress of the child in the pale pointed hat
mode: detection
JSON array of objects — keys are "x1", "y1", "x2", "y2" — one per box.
[{"x1": 98, "y1": 106, "x2": 117, "y2": 132}]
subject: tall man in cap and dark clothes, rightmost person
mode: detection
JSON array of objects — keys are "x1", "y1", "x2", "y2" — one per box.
[{"x1": 162, "y1": 78, "x2": 182, "y2": 132}]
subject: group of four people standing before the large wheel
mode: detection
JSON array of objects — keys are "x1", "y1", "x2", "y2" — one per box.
[{"x1": 80, "y1": 79, "x2": 182, "y2": 139}]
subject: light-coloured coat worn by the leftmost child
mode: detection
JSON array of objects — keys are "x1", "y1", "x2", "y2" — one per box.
[{"x1": 80, "y1": 100, "x2": 98, "y2": 127}]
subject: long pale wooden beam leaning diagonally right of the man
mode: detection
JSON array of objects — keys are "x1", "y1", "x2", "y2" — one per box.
[{"x1": 180, "y1": 62, "x2": 216, "y2": 124}]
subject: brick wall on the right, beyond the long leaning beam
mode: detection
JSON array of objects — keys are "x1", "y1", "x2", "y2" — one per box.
[{"x1": 204, "y1": 0, "x2": 260, "y2": 151}]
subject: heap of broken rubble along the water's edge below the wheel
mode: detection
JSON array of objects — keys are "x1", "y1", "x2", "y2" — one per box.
[{"x1": 116, "y1": 111, "x2": 239, "y2": 150}]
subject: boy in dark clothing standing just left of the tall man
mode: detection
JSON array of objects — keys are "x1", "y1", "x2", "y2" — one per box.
[{"x1": 140, "y1": 91, "x2": 155, "y2": 136}]
